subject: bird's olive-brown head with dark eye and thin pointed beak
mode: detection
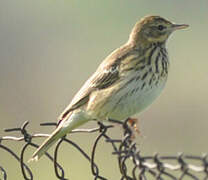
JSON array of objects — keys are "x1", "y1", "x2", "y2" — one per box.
[{"x1": 129, "y1": 16, "x2": 188, "y2": 43}]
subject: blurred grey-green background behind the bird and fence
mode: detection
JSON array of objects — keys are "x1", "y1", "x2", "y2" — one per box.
[{"x1": 0, "y1": 0, "x2": 208, "y2": 180}]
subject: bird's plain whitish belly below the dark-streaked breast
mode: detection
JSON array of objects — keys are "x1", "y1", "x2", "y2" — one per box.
[{"x1": 108, "y1": 79, "x2": 166, "y2": 120}]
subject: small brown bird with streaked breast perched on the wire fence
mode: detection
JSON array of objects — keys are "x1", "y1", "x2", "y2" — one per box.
[{"x1": 31, "y1": 15, "x2": 189, "y2": 160}]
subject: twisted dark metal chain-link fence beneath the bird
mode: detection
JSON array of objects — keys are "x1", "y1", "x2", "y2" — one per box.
[{"x1": 0, "y1": 120, "x2": 208, "y2": 180}]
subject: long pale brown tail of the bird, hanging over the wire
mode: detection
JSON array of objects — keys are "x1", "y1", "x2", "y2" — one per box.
[{"x1": 29, "y1": 114, "x2": 86, "y2": 162}]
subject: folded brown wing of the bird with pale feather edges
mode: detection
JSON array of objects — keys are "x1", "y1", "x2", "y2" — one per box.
[{"x1": 59, "y1": 43, "x2": 134, "y2": 121}]
